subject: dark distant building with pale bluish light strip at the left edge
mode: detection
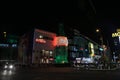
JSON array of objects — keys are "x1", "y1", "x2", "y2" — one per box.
[{"x1": 0, "y1": 32, "x2": 19, "y2": 60}]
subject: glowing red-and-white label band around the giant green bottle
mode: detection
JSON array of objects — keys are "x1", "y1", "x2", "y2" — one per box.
[{"x1": 54, "y1": 36, "x2": 68, "y2": 46}]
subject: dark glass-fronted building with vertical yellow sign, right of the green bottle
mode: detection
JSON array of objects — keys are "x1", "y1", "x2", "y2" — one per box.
[{"x1": 68, "y1": 30, "x2": 103, "y2": 63}]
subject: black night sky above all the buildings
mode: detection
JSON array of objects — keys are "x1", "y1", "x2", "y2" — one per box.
[{"x1": 0, "y1": 0, "x2": 120, "y2": 44}]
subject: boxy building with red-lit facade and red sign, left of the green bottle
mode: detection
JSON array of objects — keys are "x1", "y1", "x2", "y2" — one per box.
[{"x1": 19, "y1": 29, "x2": 56, "y2": 64}]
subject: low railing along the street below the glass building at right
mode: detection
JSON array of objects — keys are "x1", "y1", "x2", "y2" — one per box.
[{"x1": 72, "y1": 63, "x2": 120, "y2": 70}]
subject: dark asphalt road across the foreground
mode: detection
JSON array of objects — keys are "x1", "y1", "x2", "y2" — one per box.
[{"x1": 0, "y1": 67, "x2": 120, "y2": 80}]
